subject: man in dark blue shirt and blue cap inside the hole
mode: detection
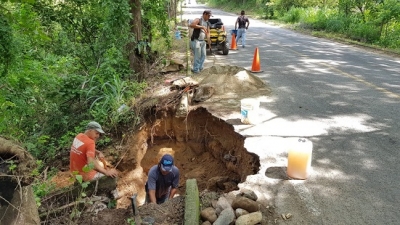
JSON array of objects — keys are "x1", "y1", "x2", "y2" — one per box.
[{"x1": 146, "y1": 154, "x2": 179, "y2": 204}]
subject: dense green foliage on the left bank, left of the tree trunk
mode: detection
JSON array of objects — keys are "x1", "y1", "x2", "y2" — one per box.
[{"x1": 0, "y1": 0, "x2": 153, "y2": 165}]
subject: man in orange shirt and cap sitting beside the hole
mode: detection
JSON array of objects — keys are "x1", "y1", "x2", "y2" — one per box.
[{"x1": 69, "y1": 121, "x2": 118, "y2": 181}]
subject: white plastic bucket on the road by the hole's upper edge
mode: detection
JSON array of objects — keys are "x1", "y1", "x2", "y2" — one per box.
[{"x1": 240, "y1": 98, "x2": 260, "y2": 124}]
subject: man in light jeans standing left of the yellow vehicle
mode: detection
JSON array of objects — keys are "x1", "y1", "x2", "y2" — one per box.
[{"x1": 190, "y1": 10, "x2": 211, "y2": 73}]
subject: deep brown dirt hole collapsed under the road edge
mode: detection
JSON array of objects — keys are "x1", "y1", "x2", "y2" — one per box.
[{"x1": 118, "y1": 107, "x2": 260, "y2": 207}]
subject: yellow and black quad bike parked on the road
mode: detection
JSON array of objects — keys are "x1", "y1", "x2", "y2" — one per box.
[{"x1": 207, "y1": 18, "x2": 229, "y2": 55}]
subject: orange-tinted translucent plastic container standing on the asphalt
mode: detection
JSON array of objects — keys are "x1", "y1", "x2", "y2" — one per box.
[{"x1": 287, "y1": 138, "x2": 313, "y2": 180}]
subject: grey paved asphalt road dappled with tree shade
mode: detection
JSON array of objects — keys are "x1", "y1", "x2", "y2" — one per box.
[{"x1": 183, "y1": 2, "x2": 400, "y2": 225}]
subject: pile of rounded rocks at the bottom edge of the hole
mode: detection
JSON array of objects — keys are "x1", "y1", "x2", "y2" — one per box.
[{"x1": 200, "y1": 191, "x2": 263, "y2": 225}]
